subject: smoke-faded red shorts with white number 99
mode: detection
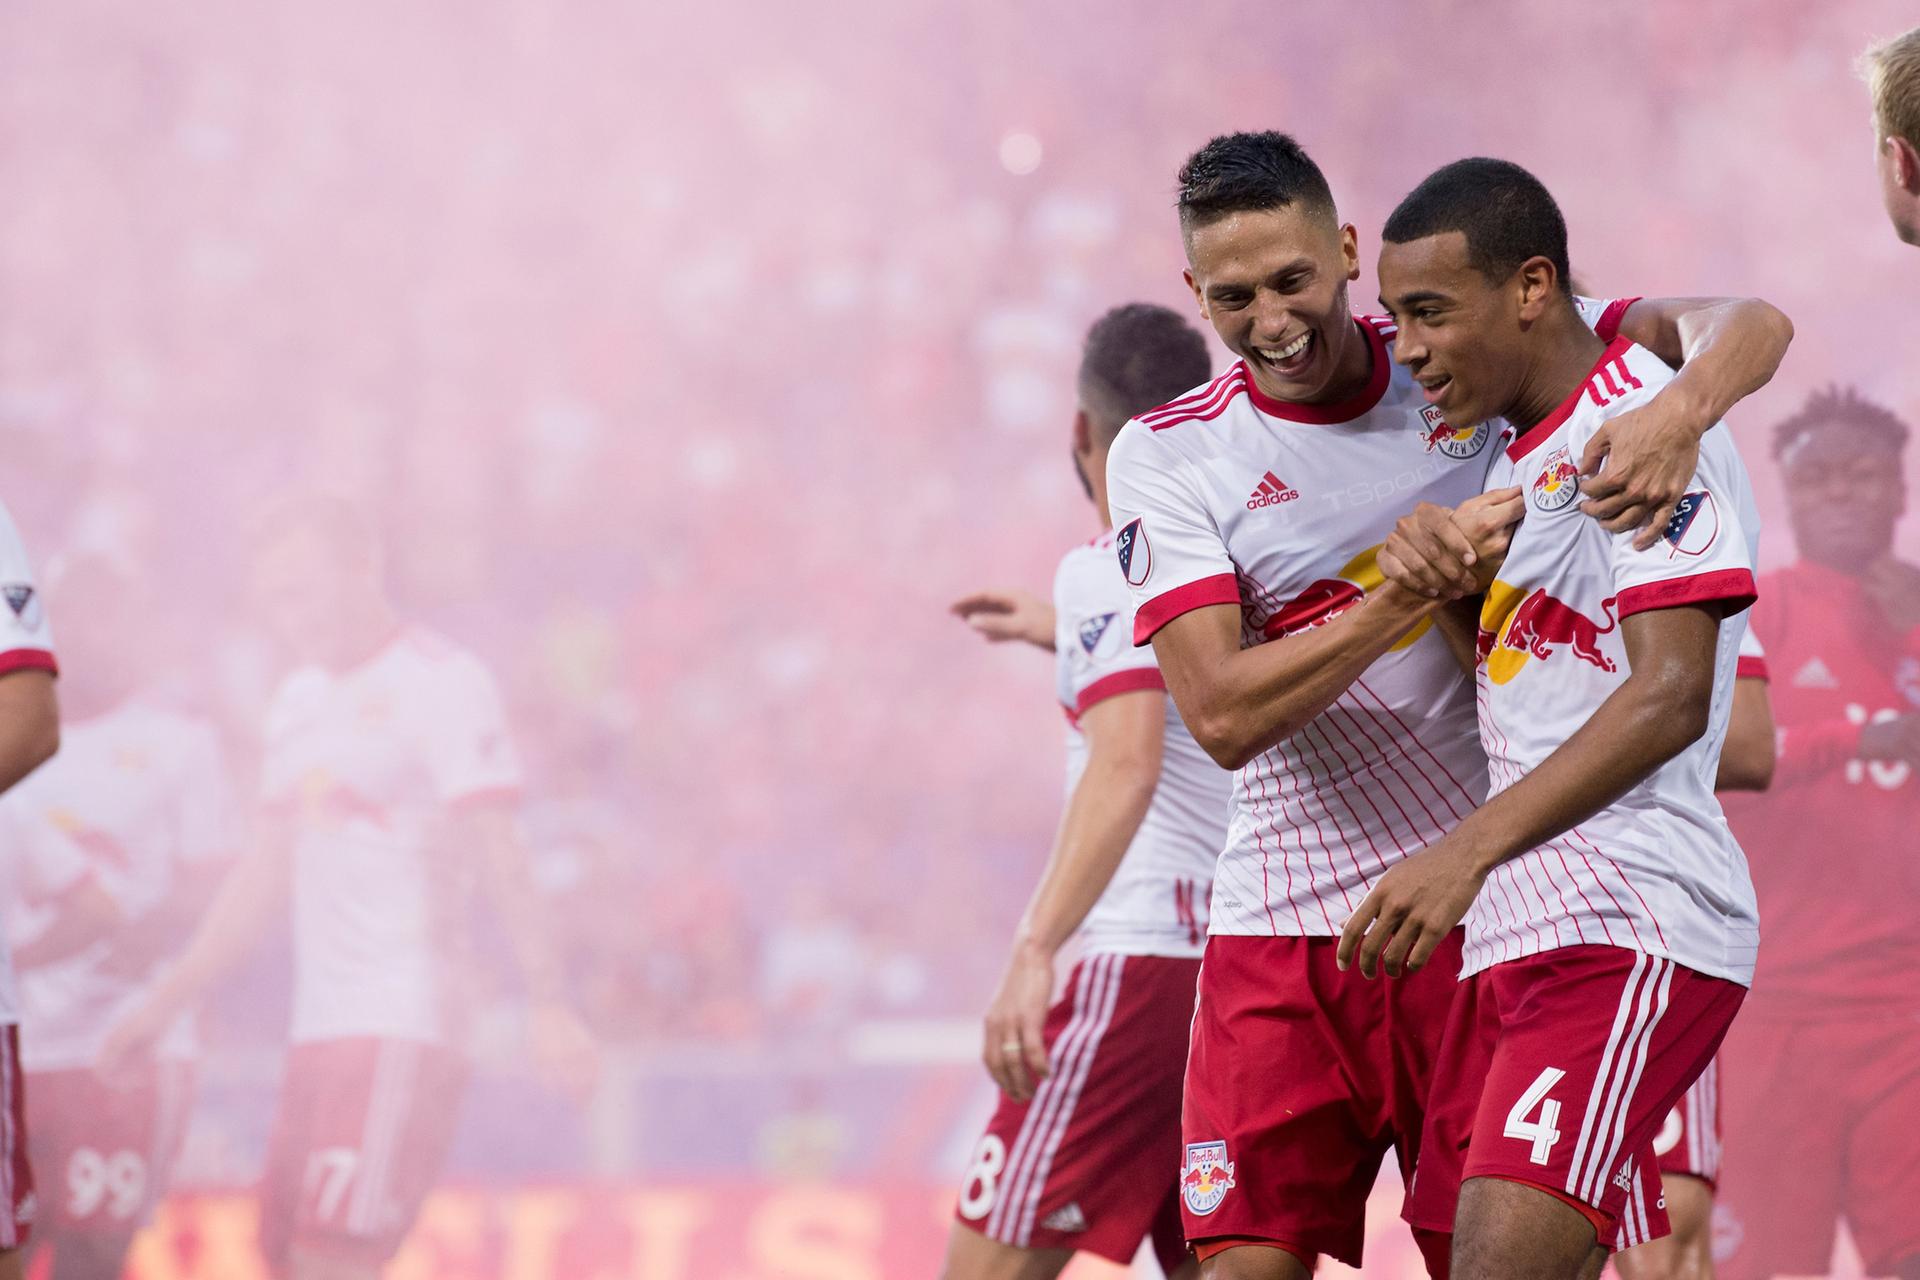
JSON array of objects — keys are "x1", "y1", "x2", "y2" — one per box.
[{"x1": 27, "y1": 1061, "x2": 194, "y2": 1238}]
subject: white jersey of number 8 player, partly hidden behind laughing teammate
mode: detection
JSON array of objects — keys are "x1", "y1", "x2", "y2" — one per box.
[{"x1": 1054, "y1": 533, "x2": 1233, "y2": 956}]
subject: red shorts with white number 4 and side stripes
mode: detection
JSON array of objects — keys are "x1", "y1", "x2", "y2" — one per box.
[{"x1": 1407, "y1": 946, "x2": 1747, "y2": 1247}]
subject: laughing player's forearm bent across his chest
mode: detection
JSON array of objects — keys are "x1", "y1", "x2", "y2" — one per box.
[{"x1": 1162, "y1": 581, "x2": 1438, "y2": 770}]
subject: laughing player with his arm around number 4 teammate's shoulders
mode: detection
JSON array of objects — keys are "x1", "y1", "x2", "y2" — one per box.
[{"x1": 1108, "y1": 132, "x2": 1788, "y2": 1280}]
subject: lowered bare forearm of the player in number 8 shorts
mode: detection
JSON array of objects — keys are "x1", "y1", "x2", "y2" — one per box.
[{"x1": 1014, "y1": 754, "x2": 1160, "y2": 956}]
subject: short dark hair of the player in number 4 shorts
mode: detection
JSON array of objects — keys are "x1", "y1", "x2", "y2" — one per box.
[{"x1": 1380, "y1": 155, "x2": 1572, "y2": 294}]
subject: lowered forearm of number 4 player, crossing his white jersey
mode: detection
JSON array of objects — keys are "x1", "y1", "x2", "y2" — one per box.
[{"x1": 1452, "y1": 672, "x2": 1707, "y2": 873}]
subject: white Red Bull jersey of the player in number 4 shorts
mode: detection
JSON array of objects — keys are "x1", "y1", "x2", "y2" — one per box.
[{"x1": 1463, "y1": 338, "x2": 1759, "y2": 983}]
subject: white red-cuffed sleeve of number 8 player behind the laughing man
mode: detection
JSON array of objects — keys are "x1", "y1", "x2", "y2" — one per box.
[{"x1": 1054, "y1": 533, "x2": 1165, "y2": 718}]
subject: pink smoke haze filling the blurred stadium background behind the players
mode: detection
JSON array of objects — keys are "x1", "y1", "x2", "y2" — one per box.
[{"x1": 0, "y1": 0, "x2": 1920, "y2": 1274}]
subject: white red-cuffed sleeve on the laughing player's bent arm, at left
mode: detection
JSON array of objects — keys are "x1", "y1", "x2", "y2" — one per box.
[{"x1": 1106, "y1": 420, "x2": 1240, "y2": 645}]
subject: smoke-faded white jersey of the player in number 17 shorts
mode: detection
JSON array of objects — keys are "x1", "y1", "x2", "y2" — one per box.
[{"x1": 261, "y1": 629, "x2": 520, "y2": 1048}]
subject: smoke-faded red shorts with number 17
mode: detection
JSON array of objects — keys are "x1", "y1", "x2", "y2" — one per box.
[{"x1": 259, "y1": 1038, "x2": 467, "y2": 1272}]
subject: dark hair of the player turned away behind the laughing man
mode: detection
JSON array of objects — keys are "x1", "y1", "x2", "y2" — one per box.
[{"x1": 1079, "y1": 301, "x2": 1213, "y2": 443}]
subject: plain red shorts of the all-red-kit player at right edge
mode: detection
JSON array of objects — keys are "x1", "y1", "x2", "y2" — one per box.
[{"x1": 1715, "y1": 1013, "x2": 1920, "y2": 1280}]
